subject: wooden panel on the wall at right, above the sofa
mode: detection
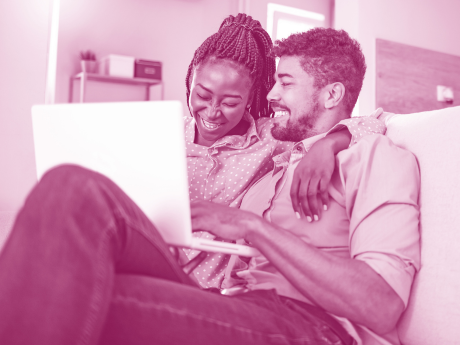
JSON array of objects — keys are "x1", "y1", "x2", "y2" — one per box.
[{"x1": 375, "y1": 39, "x2": 460, "y2": 114}]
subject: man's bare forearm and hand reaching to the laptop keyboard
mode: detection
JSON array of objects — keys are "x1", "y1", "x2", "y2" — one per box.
[{"x1": 192, "y1": 201, "x2": 404, "y2": 334}]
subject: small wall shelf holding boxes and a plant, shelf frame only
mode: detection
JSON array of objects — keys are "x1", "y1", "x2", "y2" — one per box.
[{"x1": 69, "y1": 72, "x2": 164, "y2": 103}]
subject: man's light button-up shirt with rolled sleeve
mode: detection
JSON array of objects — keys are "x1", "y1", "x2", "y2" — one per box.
[{"x1": 237, "y1": 135, "x2": 420, "y2": 344}]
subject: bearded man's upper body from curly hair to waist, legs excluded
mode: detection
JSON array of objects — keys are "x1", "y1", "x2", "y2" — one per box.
[{"x1": 192, "y1": 29, "x2": 420, "y2": 343}]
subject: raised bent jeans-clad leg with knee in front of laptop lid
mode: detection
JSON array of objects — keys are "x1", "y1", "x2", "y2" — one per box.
[{"x1": 0, "y1": 166, "x2": 193, "y2": 344}]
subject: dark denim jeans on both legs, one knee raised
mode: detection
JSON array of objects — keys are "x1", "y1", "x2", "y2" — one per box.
[{"x1": 0, "y1": 166, "x2": 348, "y2": 345}]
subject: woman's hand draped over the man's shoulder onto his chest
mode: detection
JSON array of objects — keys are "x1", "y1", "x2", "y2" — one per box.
[{"x1": 291, "y1": 128, "x2": 351, "y2": 222}]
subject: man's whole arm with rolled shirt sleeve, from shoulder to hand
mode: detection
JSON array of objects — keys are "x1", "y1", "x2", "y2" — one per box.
[{"x1": 192, "y1": 136, "x2": 420, "y2": 334}]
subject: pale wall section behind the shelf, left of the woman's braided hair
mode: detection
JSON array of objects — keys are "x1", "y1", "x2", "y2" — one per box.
[{"x1": 56, "y1": 0, "x2": 238, "y2": 111}]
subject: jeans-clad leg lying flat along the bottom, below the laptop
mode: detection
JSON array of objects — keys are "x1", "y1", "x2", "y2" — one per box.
[{"x1": 100, "y1": 275, "x2": 342, "y2": 345}]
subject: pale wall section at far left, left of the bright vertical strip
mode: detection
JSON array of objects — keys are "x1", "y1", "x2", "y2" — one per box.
[{"x1": 0, "y1": 0, "x2": 51, "y2": 212}]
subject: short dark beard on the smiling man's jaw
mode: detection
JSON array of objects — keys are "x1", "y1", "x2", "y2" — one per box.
[{"x1": 271, "y1": 100, "x2": 321, "y2": 142}]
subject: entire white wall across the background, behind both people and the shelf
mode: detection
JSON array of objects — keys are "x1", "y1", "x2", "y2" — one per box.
[{"x1": 0, "y1": 0, "x2": 460, "y2": 211}]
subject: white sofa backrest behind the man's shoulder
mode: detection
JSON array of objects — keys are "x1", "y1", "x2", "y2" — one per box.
[{"x1": 0, "y1": 107, "x2": 460, "y2": 345}]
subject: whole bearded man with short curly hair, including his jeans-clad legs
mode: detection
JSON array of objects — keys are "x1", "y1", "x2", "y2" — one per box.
[{"x1": 0, "y1": 29, "x2": 419, "y2": 345}]
